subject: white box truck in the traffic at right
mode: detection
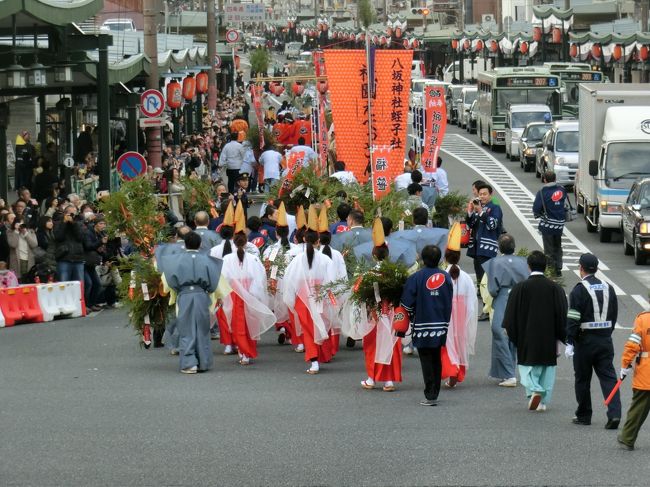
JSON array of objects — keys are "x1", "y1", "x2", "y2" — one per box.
[{"x1": 575, "y1": 84, "x2": 650, "y2": 242}]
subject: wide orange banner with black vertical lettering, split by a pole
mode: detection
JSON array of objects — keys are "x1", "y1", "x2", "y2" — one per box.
[{"x1": 324, "y1": 49, "x2": 413, "y2": 182}]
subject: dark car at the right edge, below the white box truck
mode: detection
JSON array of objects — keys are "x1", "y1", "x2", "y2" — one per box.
[{"x1": 621, "y1": 178, "x2": 650, "y2": 265}]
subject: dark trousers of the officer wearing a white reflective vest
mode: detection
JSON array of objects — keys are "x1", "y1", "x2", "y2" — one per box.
[{"x1": 573, "y1": 338, "x2": 621, "y2": 420}]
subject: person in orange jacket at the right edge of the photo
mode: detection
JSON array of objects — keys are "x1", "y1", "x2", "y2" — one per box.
[{"x1": 618, "y1": 311, "x2": 650, "y2": 450}]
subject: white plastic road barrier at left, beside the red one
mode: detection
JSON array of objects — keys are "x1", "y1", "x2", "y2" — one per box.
[{"x1": 36, "y1": 281, "x2": 86, "y2": 321}]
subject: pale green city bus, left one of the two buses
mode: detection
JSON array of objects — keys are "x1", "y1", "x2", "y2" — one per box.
[{"x1": 477, "y1": 67, "x2": 562, "y2": 150}]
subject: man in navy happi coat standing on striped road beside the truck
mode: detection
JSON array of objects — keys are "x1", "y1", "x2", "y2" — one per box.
[{"x1": 533, "y1": 171, "x2": 567, "y2": 276}]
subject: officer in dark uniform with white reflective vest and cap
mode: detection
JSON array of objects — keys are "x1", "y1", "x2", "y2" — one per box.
[{"x1": 564, "y1": 254, "x2": 621, "y2": 429}]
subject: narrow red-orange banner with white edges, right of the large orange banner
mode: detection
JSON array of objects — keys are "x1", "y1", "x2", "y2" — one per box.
[{"x1": 422, "y1": 86, "x2": 447, "y2": 173}]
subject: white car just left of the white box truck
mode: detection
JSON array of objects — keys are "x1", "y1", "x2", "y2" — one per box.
[{"x1": 536, "y1": 120, "x2": 579, "y2": 186}]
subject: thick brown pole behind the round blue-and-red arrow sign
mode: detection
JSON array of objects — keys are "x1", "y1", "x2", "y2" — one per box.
[{"x1": 142, "y1": 0, "x2": 162, "y2": 167}]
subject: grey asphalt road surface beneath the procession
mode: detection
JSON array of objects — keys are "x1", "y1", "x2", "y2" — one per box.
[{"x1": 0, "y1": 132, "x2": 650, "y2": 486}]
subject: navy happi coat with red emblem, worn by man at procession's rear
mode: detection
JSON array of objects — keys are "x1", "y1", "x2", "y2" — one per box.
[{"x1": 401, "y1": 267, "x2": 454, "y2": 348}]
